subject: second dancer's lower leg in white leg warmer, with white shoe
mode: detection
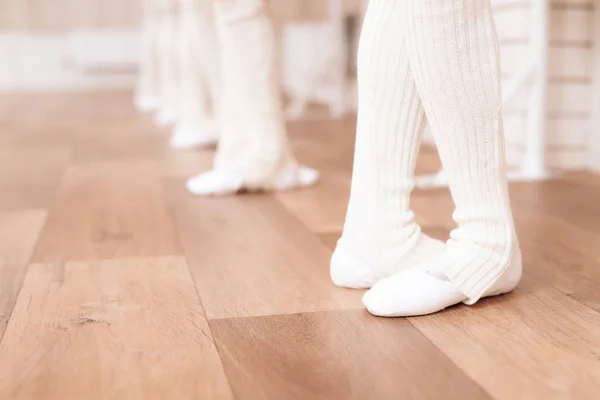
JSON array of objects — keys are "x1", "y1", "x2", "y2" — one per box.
[{"x1": 187, "y1": 0, "x2": 318, "y2": 195}]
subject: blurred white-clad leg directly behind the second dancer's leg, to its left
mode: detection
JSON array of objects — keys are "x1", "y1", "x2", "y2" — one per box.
[{"x1": 171, "y1": 0, "x2": 221, "y2": 149}]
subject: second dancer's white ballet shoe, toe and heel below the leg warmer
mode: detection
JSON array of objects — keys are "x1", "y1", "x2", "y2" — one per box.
[{"x1": 186, "y1": 165, "x2": 319, "y2": 196}]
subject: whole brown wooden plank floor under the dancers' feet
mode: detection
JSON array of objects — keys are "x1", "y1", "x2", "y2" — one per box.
[{"x1": 0, "y1": 94, "x2": 600, "y2": 400}]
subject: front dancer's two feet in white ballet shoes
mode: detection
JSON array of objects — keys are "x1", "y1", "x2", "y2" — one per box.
[{"x1": 331, "y1": 230, "x2": 522, "y2": 317}]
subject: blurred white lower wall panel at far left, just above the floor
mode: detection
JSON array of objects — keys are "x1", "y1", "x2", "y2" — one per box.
[{"x1": 0, "y1": 30, "x2": 139, "y2": 91}]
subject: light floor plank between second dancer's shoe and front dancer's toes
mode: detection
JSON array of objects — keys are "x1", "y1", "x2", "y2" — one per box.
[{"x1": 166, "y1": 181, "x2": 362, "y2": 319}]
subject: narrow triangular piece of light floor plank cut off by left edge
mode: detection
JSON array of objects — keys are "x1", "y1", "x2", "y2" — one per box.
[{"x1": 0, "y1": 210, "x2": 46, "y2": 340}]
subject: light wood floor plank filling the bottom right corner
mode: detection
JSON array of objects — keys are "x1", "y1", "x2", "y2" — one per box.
[{"x1": 411, "y1": 286, "x2": 600, "y2": 400}]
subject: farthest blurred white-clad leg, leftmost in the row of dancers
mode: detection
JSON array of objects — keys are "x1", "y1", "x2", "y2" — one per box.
[{"x1": 135, "y1": 0, "x2": 160, "y2": 112}]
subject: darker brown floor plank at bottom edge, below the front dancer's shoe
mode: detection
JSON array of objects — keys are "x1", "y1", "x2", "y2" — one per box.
[{"x1": 210, "y1": 311, "x2": 490, "y2": 400}]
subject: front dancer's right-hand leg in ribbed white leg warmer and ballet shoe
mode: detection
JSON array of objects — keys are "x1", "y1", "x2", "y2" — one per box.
[{"x1": 363, "y1": 0, "x2": 521, "y2": 316}]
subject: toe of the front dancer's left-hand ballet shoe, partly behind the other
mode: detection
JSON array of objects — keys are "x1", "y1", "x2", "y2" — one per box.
[{"x1": 330, "y1": 249, "x2": 375, "y2": 289}]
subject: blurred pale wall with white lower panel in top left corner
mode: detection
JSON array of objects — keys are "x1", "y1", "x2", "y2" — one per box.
[{"x1": 0, "y1": 0, "x2": 140, "y2": 91}]
